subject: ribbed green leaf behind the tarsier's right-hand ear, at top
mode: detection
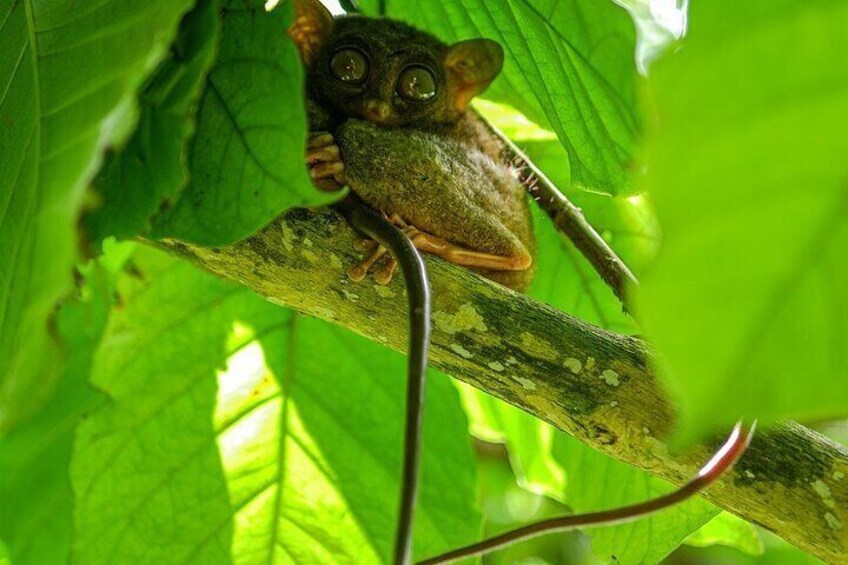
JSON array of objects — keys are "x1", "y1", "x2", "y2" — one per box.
[{"x1": 372, "y1": 0, "x2": 640, "y2": 194}]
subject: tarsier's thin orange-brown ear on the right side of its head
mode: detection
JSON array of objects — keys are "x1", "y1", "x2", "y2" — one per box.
[{"x1": 445, "y1": 39, "x2": 503, "y2": 110}]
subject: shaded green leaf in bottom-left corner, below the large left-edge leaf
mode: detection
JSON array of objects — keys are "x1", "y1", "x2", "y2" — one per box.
[{"x1": 0, "y1": 264, "x2": 111, "y2": 564}]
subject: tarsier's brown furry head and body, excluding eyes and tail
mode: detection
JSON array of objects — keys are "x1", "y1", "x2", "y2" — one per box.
[{"x1": 289, "y1": 0, "x2": 536, "y2": 290}]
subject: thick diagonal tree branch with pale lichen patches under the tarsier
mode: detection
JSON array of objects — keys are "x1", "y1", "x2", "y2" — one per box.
[{"x1": 155, "y1": 210, "x2": 848, "y2": 563}]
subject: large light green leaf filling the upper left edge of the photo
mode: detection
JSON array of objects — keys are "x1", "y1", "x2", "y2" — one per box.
[{"x1": 0, "y1": 0, "x2": 191, "y2": 429}]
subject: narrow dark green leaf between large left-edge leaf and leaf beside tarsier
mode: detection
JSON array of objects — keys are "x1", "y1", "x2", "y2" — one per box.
[{"x1": 85, "y1": 0, "x2": 219, "y2": 247}]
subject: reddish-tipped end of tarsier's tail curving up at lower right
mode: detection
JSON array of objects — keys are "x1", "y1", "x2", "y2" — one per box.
[{"x1": 418, "y1": 422, "x2": 754, "y2": 565}]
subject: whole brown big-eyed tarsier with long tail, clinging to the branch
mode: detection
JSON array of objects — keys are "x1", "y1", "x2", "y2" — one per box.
[{"x1": 289, "y1": 0, "x2": 750, "y2": 564}]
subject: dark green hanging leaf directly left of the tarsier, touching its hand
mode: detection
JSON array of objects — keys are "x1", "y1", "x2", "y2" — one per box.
[{"x1": 153, "y1": 0, "x2": 336, "y2": 245}]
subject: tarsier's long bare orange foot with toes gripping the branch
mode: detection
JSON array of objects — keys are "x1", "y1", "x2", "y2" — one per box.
[{"x1": 348, "y1": 214, "x2": 533, "y2": 284}]
